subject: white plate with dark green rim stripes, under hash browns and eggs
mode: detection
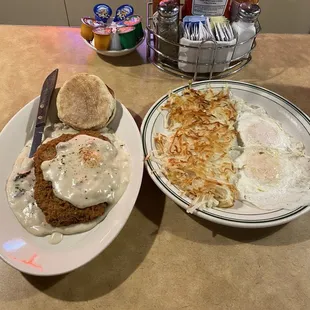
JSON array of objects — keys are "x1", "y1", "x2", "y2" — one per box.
[{"x1": 141, "y1": 81, "x2": 310, "y2": 228}]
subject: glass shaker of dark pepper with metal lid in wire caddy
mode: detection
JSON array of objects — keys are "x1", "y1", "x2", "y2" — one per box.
[{"x1": 157, "y1": 0, "x2": 179, "y2": 62}]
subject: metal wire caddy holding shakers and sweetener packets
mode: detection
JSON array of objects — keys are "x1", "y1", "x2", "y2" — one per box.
[{"x1": 146, "y1": 2, "x2": 261, "y2": 81}]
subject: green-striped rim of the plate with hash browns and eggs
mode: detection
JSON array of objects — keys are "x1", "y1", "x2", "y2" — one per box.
[{"x1": 140, "y1": 80, "x2": 310, "y2": 228}]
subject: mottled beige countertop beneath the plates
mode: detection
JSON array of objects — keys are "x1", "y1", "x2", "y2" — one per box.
[{"x1": 0, "y1": 26, "x2": 310, "y2": 310}]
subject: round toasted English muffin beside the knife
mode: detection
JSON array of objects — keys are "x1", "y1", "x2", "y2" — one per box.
[{"x1": 57, "y1": 73, "x2": 116, "y2": 130}]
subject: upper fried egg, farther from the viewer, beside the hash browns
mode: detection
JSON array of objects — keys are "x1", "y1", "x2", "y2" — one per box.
[{"x1": 236, "y1": 105, "x2": 303, "y2": 152}]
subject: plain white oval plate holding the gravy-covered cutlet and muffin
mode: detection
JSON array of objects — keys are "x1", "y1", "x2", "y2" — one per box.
[{"x1": 0, "y1": 97, "x2": 144, "y2": 276}]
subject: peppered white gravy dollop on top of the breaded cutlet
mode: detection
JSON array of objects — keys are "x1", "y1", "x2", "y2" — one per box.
[{"x1": 41, "y1": 135, "x2": 123, "y2": 209}]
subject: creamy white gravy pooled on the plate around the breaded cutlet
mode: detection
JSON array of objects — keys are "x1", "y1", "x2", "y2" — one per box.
[{"x1": 6, "y1": 124, "x2": 130, "y2": 244}]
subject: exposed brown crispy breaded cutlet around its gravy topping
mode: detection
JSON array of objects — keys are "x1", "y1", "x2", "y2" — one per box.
[{"x1": 34, "y1": 130, "x2": 110, "y2": 227}]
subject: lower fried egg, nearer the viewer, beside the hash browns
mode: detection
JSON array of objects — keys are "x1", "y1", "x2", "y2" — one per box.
[{"x1": 235, "y1": 147, "x2": 310, "y2": 210}]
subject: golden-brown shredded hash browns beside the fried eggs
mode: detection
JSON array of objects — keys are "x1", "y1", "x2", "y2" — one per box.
[{"x1": 150, "y1": 89, "x2": 238, "y2": 213}]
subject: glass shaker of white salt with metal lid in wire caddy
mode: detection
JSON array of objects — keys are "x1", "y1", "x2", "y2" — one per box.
[{"x1": 232, "y1": 3, "x2": 261, "y2": 60}]
